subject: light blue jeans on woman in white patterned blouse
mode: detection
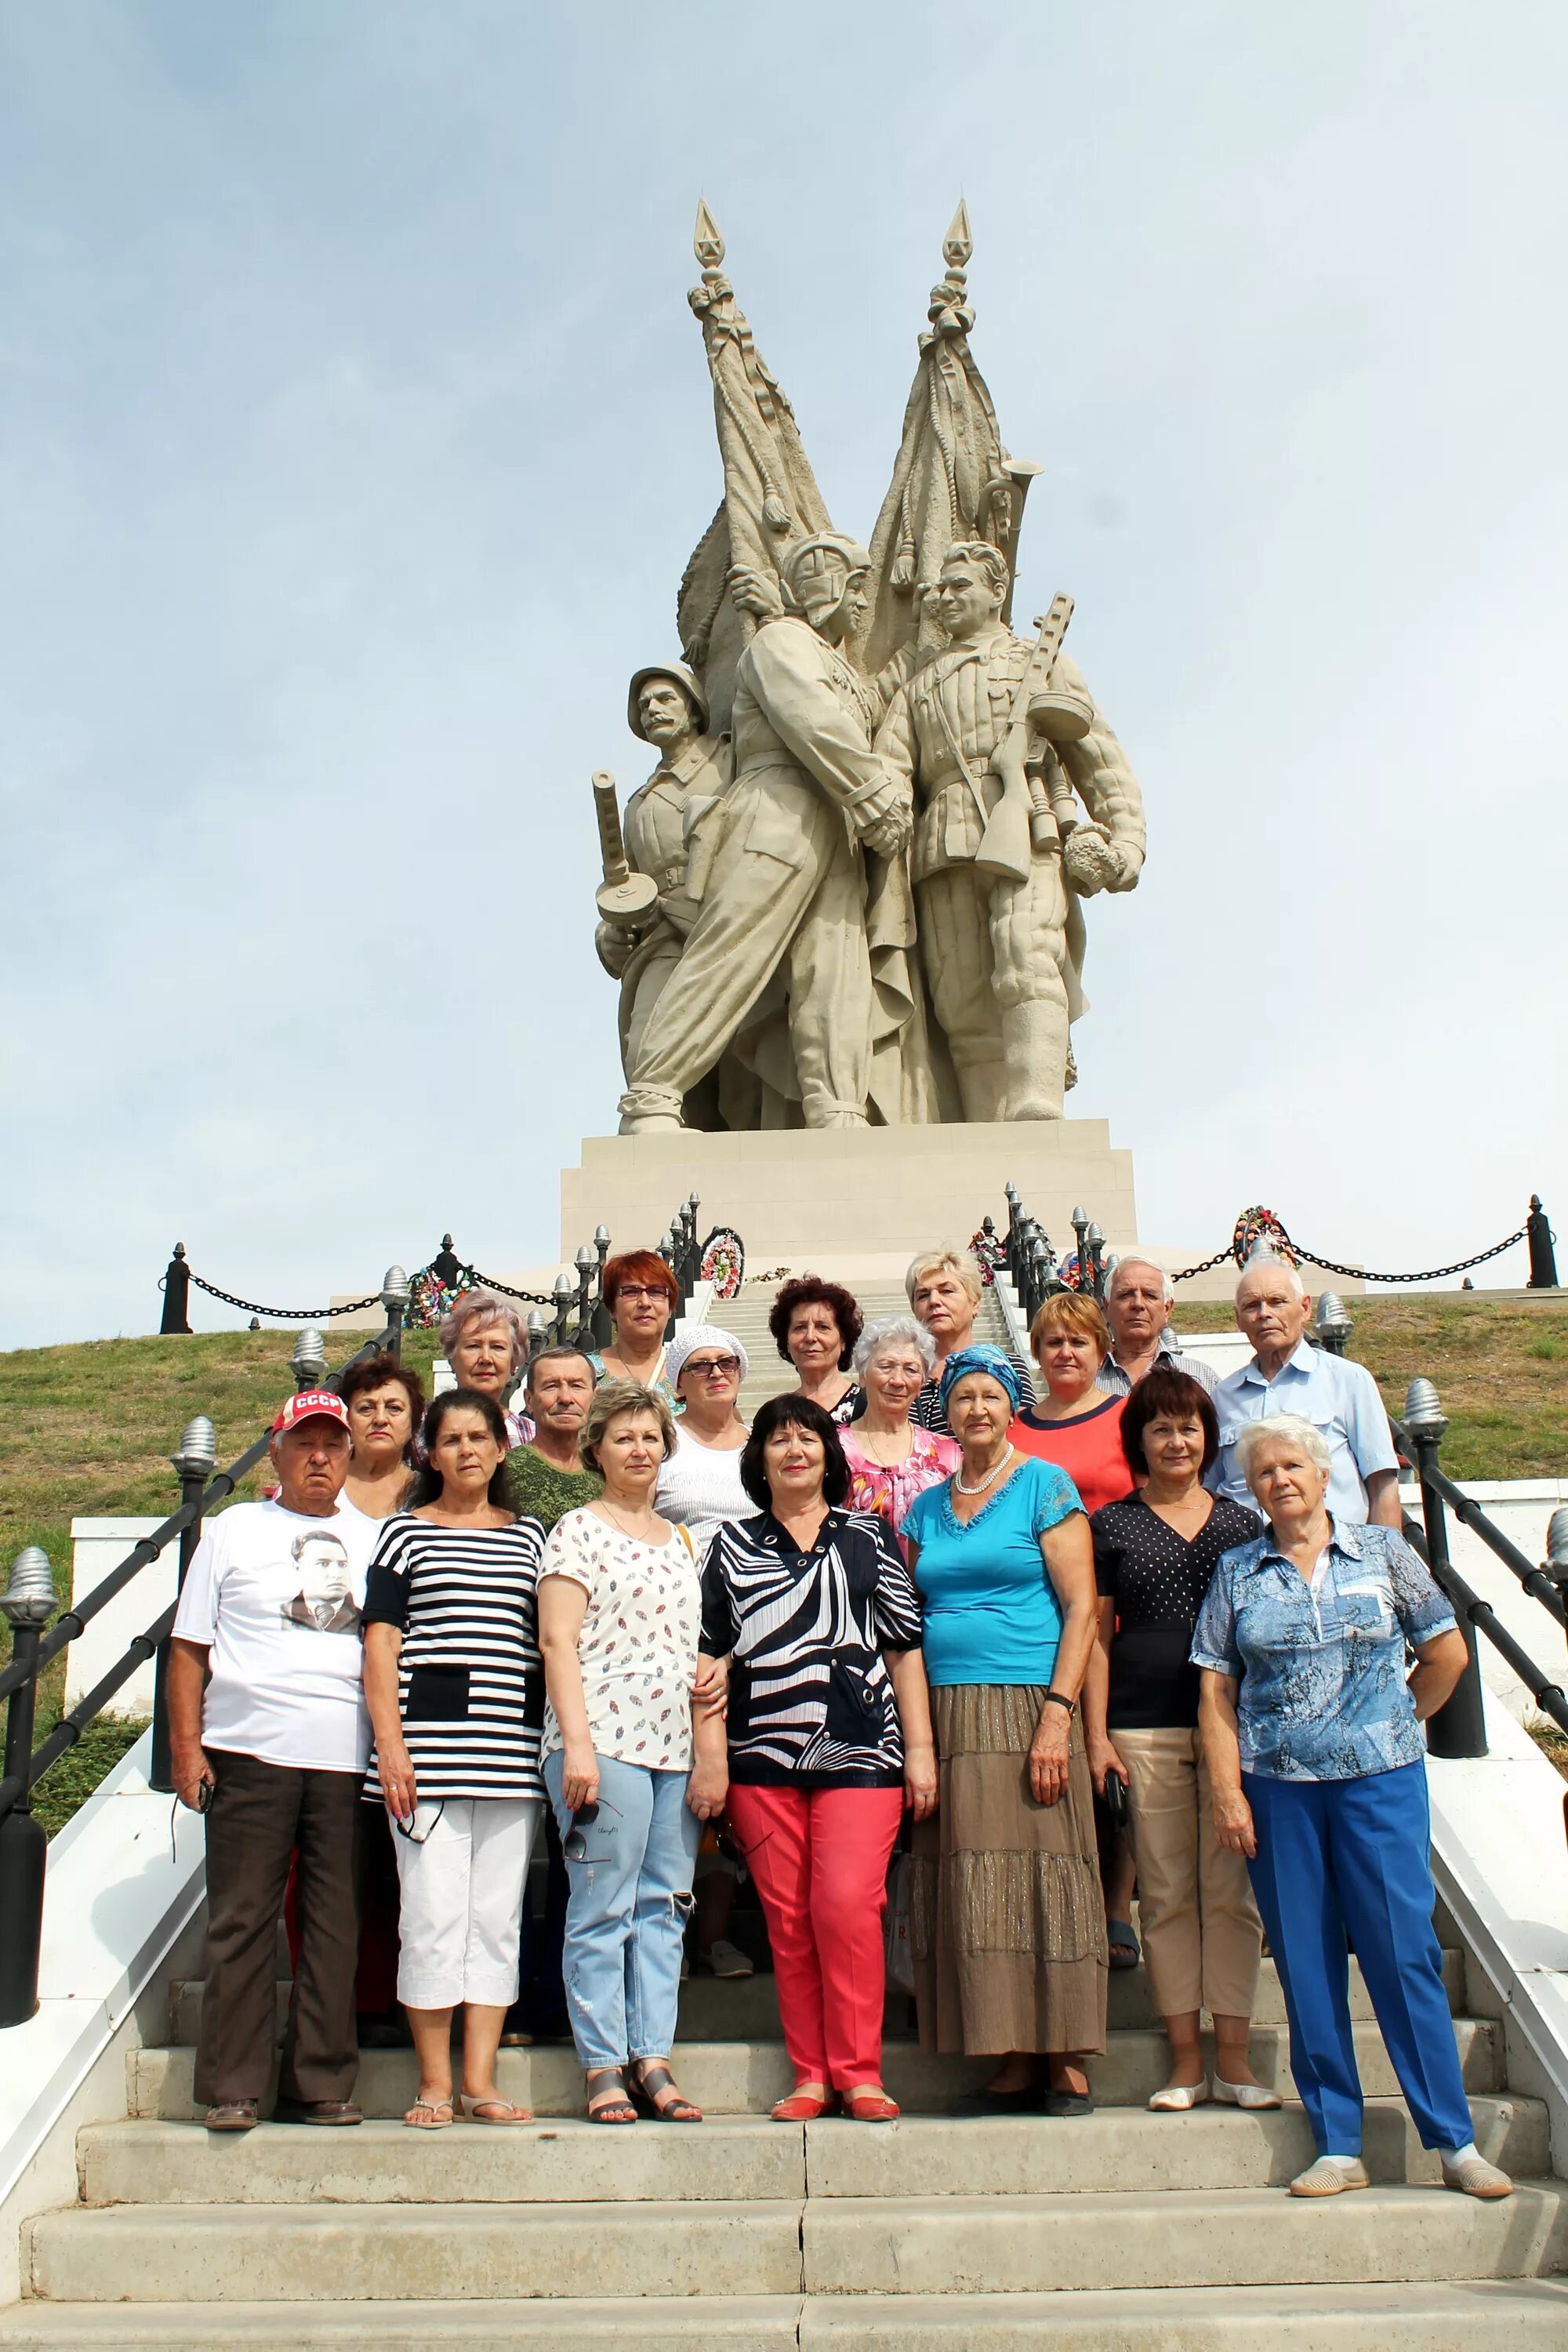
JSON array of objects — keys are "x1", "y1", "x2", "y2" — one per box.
[{"x1": 546, "y1": 1748, "x2": 703, "y2": 2067}]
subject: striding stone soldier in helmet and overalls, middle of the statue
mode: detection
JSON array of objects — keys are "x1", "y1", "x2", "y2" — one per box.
[{"x1": 621, "y1": 532, "x2": 909, "y2": 1134}]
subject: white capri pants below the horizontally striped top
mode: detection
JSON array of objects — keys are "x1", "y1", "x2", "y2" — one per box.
[{"x1": 393, "y1": 1797, "x2": 543, "y2": 2009}]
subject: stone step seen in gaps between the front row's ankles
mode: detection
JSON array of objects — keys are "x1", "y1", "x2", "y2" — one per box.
[{"x1": 127, "y1": 2018, "x2": 1502, "y2": 2122}]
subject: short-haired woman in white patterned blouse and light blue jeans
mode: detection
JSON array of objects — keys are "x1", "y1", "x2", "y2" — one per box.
[{"x1": 539, "y1": 1381, "x2": 724, "y2": 2124}]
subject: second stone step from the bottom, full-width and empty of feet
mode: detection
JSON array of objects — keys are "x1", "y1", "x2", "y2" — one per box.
[{"x1": 24, "y1": 2183, "x2": 1568, "y2": 2303}]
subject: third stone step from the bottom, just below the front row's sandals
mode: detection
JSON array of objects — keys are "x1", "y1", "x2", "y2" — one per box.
[{"x1": 78, "y1": 2096, "x2": 1552, "y2": 2206}]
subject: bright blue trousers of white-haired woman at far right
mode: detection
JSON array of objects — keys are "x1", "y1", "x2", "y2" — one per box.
[{"x1": 1241, "y1": 1764, "x2": 1472, "y2": 2157}]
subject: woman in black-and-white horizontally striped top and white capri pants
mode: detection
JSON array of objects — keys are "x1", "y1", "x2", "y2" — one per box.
[{"x1": 362, "y1": 1388, "x2": 546, "y2": 2131}]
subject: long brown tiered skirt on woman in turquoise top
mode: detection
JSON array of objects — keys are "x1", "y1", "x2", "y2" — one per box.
[{"x1": 909, "y1": 1684, "x2": 1107, "y2": 2056}]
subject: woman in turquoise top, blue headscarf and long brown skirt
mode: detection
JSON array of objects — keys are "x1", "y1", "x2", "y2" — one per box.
[{"x1": 902, "y1": 1348, "x2": 1107, "y2": 2114}]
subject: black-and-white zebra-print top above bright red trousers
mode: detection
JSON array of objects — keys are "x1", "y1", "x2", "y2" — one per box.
[{"x1": 703, "y1": 1510, "x2": 921, "y2": 1788}]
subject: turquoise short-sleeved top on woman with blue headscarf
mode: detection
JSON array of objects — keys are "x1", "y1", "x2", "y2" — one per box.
[{"x1": 902, "y1": 1458, "x2": 1083, "y2": 1686}]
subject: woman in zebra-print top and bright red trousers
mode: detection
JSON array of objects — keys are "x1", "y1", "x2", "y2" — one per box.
[{"x1": 696, "y1": 1395, "x2": 935, "y2": 2124}]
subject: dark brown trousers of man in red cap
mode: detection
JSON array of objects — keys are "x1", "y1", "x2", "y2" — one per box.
[{"x1": 195, "y1": 1748, "x2": 365, "y2": 2107}]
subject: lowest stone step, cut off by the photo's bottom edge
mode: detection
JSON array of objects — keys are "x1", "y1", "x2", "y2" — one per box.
[{"x1": 0, "y1": 2279, "x2": 1568, "y2": 2352}]
